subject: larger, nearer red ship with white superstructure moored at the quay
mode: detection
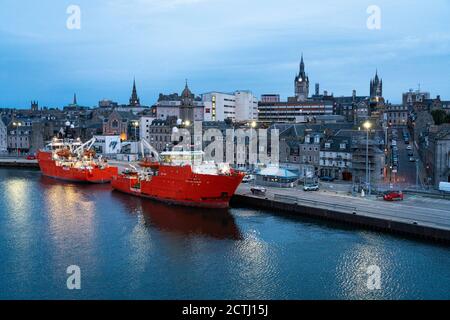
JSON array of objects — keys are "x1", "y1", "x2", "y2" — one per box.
[{"x1": 111, "y1": 142, "x2": 244, "y2": 208}]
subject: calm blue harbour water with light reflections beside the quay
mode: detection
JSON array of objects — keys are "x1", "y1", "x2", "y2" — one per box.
[{"x1": 0, "y1": 170, "x2": 450, "y2": 299}]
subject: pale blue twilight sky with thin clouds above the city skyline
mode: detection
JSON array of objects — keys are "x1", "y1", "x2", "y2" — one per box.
[{"x1": 0, "y1": 0, "x2": 450, "y2": 108}]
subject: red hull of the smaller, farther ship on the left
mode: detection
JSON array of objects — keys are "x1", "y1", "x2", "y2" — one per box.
[{"x1": 37, "y1": 151, "x2": 118, "y2": 183}]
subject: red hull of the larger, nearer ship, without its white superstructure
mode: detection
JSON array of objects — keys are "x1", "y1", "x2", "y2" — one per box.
[{"x1": 111, "y1": 166, "x2": 244, "y2": 208}]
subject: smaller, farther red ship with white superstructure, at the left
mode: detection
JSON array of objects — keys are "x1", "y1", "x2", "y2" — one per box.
[{"x1": 37, "y1": 139, "x2": 118, "y2": 183}]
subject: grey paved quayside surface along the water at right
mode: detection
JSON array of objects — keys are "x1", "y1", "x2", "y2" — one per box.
[{"x1": 241, "y1": 184, "x2": 450, "y2": 230}]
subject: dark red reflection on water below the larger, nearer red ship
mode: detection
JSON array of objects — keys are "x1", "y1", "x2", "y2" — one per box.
[{"x1": 113, "y1": 192, "x2": 241, "y2": 240}]
